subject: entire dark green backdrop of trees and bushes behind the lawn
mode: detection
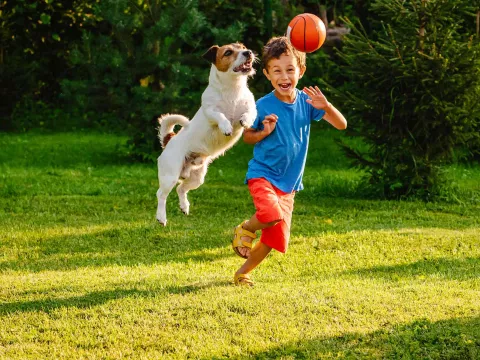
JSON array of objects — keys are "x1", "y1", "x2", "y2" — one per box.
[{"x1": 0, "y1": 0, "x2": 480, "y2": 200}]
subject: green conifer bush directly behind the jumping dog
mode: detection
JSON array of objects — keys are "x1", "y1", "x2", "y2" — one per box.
[{"x1": 62, "y1": 0, "x2": 214, "y2": 160}]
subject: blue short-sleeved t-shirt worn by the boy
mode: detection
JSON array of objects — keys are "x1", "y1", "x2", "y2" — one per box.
[{"x1": 245, "y1": 89, "x2": 325, "y2": 193}]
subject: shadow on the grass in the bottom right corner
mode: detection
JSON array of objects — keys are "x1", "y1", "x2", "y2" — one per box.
[{"x1": 226, "y1": 317, "x2": 480, "y2": 360}]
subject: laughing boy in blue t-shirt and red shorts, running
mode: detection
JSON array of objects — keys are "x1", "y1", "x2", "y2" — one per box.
[{"x1": 232, "y1": 37, "x2": 347, "y2": 286}]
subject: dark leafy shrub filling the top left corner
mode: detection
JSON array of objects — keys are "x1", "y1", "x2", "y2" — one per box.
[{"x1": 0, "y1": 0, "x2": 98, "y2": 130}]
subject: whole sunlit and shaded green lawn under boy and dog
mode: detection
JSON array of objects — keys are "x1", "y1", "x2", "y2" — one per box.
[{"x1": 0, "y1": 126, "x2": 480, "y2": 359}]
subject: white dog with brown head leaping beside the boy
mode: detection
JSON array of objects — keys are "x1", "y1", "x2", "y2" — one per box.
[{"x1": 156, "y1": 43, "x2": 257, "y2": 226}]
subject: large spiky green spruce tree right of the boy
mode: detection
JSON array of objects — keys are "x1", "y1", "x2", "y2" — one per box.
[{"x1": 330, "y1": 0, "x2": 480, "y2": 199}]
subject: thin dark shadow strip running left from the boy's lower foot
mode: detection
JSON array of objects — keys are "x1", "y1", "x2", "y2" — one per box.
[{"x1": 0, "y1": 281, "x2": 231, "y2": 315}]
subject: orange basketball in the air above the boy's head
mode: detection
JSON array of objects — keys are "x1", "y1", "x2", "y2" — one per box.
[{"x1": 287, "y1": 13, "x2": 327, "y2": 53}]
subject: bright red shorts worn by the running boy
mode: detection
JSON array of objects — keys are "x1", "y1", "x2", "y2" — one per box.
[{"x1": 248, "y1": 178, "x2": 295, "y2": 253}]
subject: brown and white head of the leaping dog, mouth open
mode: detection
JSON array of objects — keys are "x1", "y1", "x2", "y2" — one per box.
[{"x1": 203, "y1": 43, "x2": 255, "y2": 75}]
